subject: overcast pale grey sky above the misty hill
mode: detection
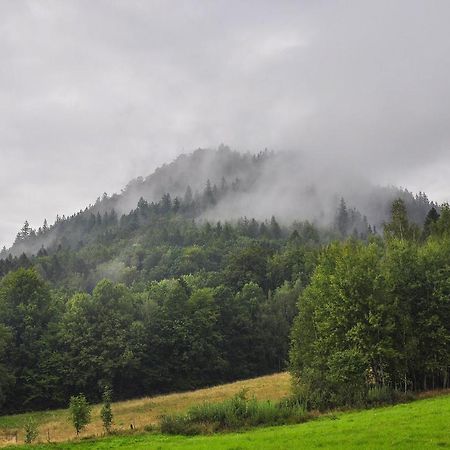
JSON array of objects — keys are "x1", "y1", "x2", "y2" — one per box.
[{"x1": 0, "y1": 0, "x2": 450, "y2": 246}]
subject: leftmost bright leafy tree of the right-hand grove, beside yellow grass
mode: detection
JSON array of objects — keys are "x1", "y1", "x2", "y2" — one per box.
[{"x1": 291, "y1": 242, "x2": 389, "y2": 407}]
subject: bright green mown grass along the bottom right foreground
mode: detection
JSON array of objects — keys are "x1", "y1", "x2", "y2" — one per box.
[{"x1": 7, "y1": 395, "x2": 450, "y2": 450}]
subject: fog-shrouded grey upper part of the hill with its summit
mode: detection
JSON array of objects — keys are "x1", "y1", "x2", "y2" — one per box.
[{"x1": 0, "y1": 145, "x2": 436, "y2": 258}]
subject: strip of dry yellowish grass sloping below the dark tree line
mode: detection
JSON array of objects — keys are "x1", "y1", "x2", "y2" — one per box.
[{"x1": 0, "y1": 373, "x2": 291, "y2": 446}]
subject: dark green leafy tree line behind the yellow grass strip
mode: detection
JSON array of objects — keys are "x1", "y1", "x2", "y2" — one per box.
[{"x1": 0, "y1": 237, "x2": 316, "y2": 412}]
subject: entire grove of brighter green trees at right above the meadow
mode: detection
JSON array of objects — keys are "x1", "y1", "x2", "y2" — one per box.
[{"x1": 291, "y1": 201, "x2": 450, "y2": 408}]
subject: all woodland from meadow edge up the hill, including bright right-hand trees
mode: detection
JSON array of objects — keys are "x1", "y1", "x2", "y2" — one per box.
[{"x1": 0, "y1": 149, "x2": 450, "y2": 412}]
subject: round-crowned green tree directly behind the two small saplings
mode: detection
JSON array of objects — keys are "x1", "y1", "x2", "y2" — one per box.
[{"x1": 59, "y1": 280, "x2": 139, "y2": 396}]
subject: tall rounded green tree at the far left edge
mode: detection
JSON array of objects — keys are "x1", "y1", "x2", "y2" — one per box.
[{"x1": 0, "y1": 269, "x2": 56, "y2": 408}]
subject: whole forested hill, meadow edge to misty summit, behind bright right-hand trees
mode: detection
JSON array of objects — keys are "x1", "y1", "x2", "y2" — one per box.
[{"x1": 0, "y1": 148, "x2": 444, "y2": 412}]
